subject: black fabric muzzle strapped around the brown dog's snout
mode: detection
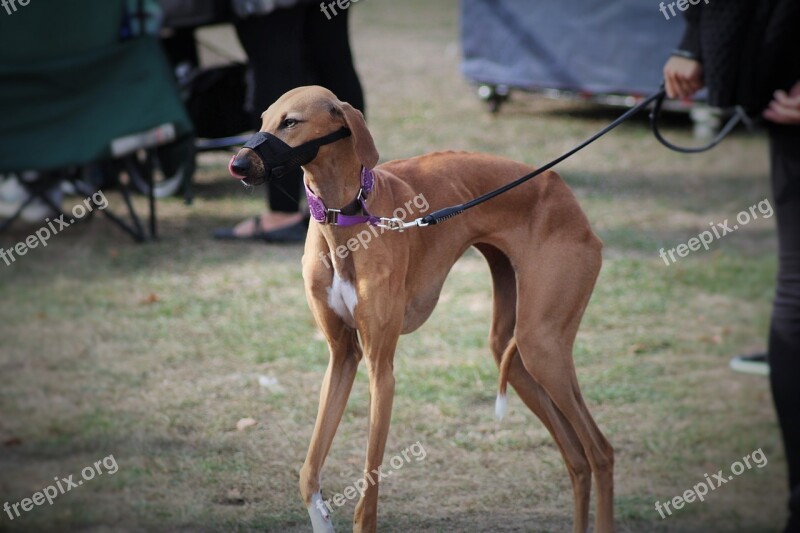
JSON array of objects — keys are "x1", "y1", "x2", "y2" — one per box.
[{"x1": 231, "y1": 128, "x2": 350, "y2": 180}]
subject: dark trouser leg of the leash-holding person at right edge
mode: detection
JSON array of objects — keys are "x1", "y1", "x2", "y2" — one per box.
[{"x1": 769, "y1": 127, "x2": 800, "y2": 533}]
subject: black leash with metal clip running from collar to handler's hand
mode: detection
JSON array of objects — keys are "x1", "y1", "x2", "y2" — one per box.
[{"x1": 406, "y1": 85, "x2": 752, "y2": 231}]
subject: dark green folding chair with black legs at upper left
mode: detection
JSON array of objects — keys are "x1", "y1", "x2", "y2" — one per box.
[{"x1": 0, "y1": 0, "x2": 194, "y2": 241}]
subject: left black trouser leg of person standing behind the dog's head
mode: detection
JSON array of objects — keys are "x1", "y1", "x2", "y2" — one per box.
[{"x1": 236, "y1": 6, "x2": 309, "y2": 213}]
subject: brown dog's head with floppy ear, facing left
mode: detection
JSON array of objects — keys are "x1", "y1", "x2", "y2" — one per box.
[{"x1": 229, "y1": 86, "x2": 378, "y2": 185}]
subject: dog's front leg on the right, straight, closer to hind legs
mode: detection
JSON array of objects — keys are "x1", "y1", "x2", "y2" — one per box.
[{"x1": 353, "y1": 326, "x2": 402, "y2": 533}]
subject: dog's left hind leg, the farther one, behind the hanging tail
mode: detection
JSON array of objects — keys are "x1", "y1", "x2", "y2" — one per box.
[{"x1": 478, "y1": 245, "x2": 592, "y2": 533}]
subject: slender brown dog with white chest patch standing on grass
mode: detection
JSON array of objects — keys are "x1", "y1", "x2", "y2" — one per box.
[{"x1": 231, "y1": 87, "x2": 614, "y2": 533}]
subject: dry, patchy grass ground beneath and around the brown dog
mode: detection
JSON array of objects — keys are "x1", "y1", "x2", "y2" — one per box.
[{"x1": 0, "y1": 0, "x2": 786, "y2": 532}]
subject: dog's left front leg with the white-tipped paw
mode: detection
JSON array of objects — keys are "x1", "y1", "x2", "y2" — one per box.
[{"x1": 300, "y1": 327, "x2": 361, "y2": 533}]
